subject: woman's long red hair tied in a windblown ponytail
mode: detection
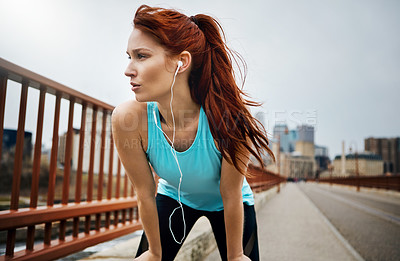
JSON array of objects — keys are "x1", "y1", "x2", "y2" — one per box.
[{"x1": 133, "y1": 5, "x2": 275, "y2": 175}]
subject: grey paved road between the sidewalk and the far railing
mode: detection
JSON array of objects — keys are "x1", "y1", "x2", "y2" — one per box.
[{"x1": 299, "y1": 183, "x2": 400, "y2": 260}]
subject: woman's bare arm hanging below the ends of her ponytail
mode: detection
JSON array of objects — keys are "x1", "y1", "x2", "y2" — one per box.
[{"x1": 220, "y1": 152, "x2": 250, "y2": 261}]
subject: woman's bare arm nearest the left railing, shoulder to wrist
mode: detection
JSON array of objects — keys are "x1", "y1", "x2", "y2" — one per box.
[{"x1": 112, "y1": 101, "x2": 162, "y2": 260}]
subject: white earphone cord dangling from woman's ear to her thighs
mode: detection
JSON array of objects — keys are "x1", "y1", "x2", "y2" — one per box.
[{"x1": 153, "y1": 61, "x2": 186, "y2": 244}]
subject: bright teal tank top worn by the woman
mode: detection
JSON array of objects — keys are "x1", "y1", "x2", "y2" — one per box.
[{"x1": 146, "y1": 102, "x2": 254, "y2": 211}]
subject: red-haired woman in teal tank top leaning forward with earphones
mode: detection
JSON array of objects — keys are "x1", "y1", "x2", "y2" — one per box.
[{"x1": 112, "y1": 5, "x2": 273, "y2": 260}]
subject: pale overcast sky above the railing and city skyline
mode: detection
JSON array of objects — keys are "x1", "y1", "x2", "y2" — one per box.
[{"x1": 0, "y1": 0, "x2": 400, "y2": 157}]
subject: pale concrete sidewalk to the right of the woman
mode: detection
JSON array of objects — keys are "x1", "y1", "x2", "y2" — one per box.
[{"x1": 252, "y1": 183, "x2": 360, "y2": 261}]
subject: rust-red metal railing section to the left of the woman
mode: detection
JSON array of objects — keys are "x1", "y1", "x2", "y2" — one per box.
[{"x1": 0, "y1": 58, "x2": 141, "y2": 260}]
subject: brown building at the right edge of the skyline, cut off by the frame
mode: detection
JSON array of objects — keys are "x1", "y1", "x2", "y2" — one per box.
[{"x1": 364, "y1": 137, "x2": 400, "y2": 174}]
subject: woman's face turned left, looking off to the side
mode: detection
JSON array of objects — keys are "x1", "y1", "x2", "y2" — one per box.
[{"x1": 125, "y1": 28, "x2": 175, "y2": 102}]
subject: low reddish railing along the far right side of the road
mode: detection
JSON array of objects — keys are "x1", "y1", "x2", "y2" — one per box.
[{"x1": 313, "y1": 175, "x2": 400, "y2": 191}]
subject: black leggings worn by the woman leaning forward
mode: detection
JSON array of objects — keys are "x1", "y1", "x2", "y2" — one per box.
[{"x1": 136, "y1": 194, "x2": 259, "y2": 261}]
